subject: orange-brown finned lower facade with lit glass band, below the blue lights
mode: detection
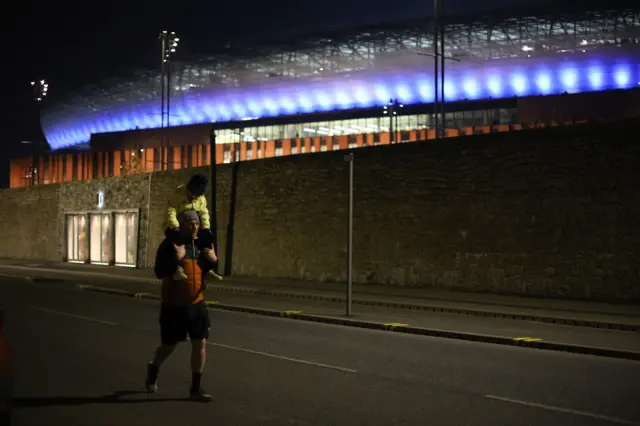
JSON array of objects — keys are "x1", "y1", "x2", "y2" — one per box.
[{"x1": 11, "y1": 103, "x2": 530, "y2": 188}]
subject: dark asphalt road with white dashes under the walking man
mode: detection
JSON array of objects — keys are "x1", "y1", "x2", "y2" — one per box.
[{"x1": 0, "y1": 279, "x2": 640, "y2": 426}]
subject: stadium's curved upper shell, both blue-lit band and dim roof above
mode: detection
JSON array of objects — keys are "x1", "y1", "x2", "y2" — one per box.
[{"x1": 42, "y1": 8, "x2": 640, "y2": 150}]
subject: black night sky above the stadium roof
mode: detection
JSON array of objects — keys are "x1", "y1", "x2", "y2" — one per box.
[{"x1": 0, "y1": 0, "x2": 616, "y2": 187}]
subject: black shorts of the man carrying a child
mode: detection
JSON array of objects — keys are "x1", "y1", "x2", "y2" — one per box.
[{"x1": 160, "y1": 302, "x2": 211, "y2": 345}]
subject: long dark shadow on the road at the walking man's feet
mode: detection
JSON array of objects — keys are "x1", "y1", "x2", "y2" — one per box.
[{"x1": 13, "y1": 391, "x2": 189, "y2": 408}]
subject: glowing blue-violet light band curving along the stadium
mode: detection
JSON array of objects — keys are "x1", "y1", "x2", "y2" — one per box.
[{"x1": 44, "y1": 49, "x2": 640, "y2": 149}]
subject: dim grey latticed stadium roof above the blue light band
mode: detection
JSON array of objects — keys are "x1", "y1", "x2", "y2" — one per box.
[{"x1": 43, "y1": 4, "x2": 640, "y2": 146}]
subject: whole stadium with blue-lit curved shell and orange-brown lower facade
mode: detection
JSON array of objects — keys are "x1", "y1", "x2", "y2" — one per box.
[{"x1": 11, "y1": 2, "x2": 640, "y2": 187}]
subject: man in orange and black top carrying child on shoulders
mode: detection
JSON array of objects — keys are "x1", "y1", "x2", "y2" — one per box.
[{"x1": 145, "y1": 210, "x2": 217, "y2": 402}]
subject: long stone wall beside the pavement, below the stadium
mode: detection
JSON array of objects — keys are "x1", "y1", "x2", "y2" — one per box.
[{"x1": 0, "y1": 121, "x2": 640, "y2": 300}]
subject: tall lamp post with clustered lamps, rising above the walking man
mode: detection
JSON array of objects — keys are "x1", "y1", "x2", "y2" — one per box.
[{"x1": 158, "y1": 31, "x2": 180, "y2": 170}]
